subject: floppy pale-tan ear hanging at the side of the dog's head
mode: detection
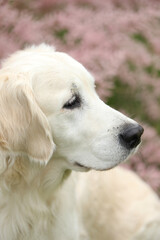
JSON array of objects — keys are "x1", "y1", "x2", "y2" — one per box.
[{"x1": 0, "y1": 74, "x2": 55, "y2": 172}]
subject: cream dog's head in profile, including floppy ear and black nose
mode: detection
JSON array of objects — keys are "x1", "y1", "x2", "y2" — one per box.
[{"x1": 0, "y1": 44, "x2": 143, "y2": 171}]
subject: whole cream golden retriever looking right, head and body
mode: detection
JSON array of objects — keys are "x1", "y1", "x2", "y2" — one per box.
[{"x1": 0, "y1": 44, "x2": 160, "y2": 240}]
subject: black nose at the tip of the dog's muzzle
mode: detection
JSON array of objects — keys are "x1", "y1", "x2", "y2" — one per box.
[{"x1": 119, "y1": 124, "x2": 144, "y2": 149}]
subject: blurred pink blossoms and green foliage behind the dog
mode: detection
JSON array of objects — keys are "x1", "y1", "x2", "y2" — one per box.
[{"x1": 0, "y1": 0, "x2": 160, "y2": 195}]
